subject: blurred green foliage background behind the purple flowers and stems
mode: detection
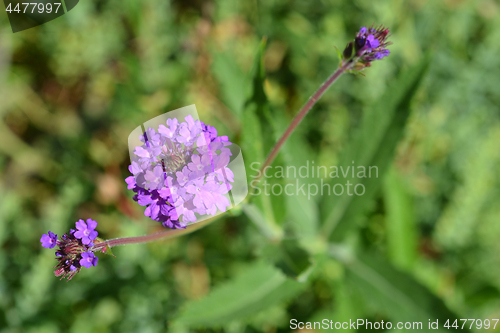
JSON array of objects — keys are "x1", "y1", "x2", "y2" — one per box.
[{"x1": 0, "y1": 0, "x2": 500, "y2": 333}]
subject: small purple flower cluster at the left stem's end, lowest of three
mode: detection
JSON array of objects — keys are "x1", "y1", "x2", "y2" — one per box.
[{"x1": 40, "y1": 219, "x2": 98, "y2": 281}]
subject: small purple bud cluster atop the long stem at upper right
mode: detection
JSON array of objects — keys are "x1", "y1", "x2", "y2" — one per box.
[{"x1": 343, "y1": 25, "x2": 392, "y2": 70}]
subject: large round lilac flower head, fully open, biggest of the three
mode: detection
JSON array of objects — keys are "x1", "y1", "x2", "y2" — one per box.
[{"x1": 125, "y1": 115, "x2": 234, "y2": 229}]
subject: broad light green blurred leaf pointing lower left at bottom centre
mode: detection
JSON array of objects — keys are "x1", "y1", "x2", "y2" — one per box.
[{"x1": 174, "y1": 263, "x2": 307, "y2": 328}]
